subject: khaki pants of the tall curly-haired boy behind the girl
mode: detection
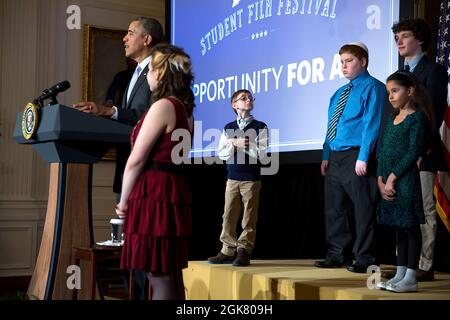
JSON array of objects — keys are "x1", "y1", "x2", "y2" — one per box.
[{"x1": 419, "y1": 171, "x2": 437, "y2": 271}]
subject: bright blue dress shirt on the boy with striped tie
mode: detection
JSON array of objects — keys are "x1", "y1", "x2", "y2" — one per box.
[{"x1": 322, "y1": 70, "x2": 387, "y2": 162}]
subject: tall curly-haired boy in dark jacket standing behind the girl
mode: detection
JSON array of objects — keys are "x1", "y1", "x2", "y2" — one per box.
[{"x1": 392, "y1": 19, "x2": 448, "y2": 281}]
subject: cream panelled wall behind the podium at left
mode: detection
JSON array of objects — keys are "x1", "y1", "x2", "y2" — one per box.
[{"x1": 0, "y1": 0, "x2": 165, "y2": 277}]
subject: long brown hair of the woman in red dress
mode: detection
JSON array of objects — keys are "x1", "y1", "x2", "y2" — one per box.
[{"x1": 151, "y1": 43, "x2": 195, "y2": 116}]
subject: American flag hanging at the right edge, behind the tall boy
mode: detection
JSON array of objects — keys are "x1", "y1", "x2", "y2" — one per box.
[{"x1": 434, "y1": 0, "x2": 450, "y2": 232}]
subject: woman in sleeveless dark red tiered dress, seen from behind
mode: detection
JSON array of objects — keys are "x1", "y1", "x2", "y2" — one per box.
[{"x1": 116, "y1": 44, "x2": 194, "y2": 300}]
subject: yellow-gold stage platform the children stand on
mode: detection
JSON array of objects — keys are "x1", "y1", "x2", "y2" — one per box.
[{"x1": 183, "y1": 260, "x2": 450, "y2": 300}]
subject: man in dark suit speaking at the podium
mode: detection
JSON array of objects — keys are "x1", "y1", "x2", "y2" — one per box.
[{"x1": 73, "y1": 17, "x2": 163, "y2": 298}]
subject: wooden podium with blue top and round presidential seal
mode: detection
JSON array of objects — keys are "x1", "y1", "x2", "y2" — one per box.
[{"x1": 13, "y1": 104, "x2": 132, "y2": 300}]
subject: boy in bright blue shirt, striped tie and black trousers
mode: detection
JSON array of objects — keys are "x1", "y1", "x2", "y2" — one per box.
[{"x1": 315, "y1": 42, "x2": 387, "y2": 273}]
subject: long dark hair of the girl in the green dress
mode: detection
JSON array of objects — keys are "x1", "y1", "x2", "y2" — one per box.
[{"x1": 386, "y1": 71, "x2": 435, "y2": 133}]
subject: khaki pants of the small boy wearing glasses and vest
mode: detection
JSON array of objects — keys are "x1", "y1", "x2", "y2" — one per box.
[{"x1": 220, "y1": 179, "x2": 261, "y2": 256}]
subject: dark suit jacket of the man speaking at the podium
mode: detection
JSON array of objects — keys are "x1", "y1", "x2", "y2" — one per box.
[{"x1": 113, "y1": 66, "x2": 151, "y2": 193}]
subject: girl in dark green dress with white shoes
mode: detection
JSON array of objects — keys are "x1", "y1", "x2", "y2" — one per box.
[{"x1": 377, "y1": 71, "x2": 433, "y2": 292}]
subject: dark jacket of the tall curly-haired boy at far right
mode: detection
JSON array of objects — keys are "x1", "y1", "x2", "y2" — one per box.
[{"x1": 413, "y1": 56, "x2": 448, "y2": 172}]
